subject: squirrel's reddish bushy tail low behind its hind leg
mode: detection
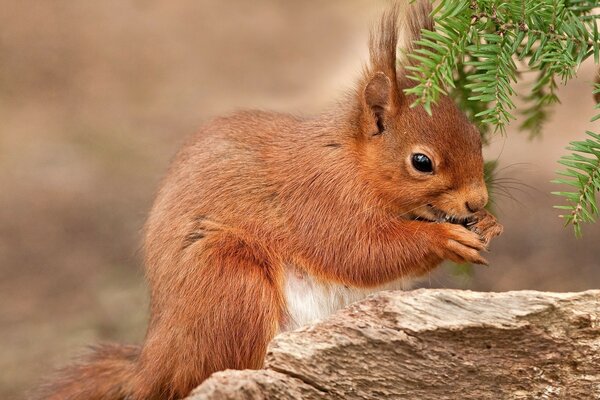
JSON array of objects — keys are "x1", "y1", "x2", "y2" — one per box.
[{"x1": 34, "y1": 345, "x2": 140, "y2": 400}]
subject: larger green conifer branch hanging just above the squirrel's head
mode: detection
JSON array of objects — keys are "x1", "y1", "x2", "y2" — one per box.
[{"x1": 406, "y1": 0, "x2": 600, "y2": 136}]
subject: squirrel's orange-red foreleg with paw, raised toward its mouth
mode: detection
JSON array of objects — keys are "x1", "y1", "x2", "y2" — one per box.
[{"x1": 299, "y1": 219, "x2": 487, "y2": 287}]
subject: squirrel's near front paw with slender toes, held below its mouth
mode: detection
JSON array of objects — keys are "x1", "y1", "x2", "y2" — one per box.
[{"x1": 438, "y1": 223, "x2": 488, "y2": 265}]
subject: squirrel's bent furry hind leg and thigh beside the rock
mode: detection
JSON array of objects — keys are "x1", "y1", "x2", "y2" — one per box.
[{"x1": 131, "y1": 232, "x2": 283, "y2": 400}]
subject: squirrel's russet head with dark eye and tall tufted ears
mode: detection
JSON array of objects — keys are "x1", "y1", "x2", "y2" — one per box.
[{"x1": 356, "y1": 0, "x2": 488, "y2": 222}]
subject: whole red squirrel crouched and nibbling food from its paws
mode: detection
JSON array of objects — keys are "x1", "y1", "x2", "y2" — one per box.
[{"x1": 42, "y1": 0, "x2": 502, "y2": 400}]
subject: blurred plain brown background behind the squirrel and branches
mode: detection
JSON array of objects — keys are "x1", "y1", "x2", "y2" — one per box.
[{"x1": 0, "y1": 0, "x2": 600, "y2": 399}]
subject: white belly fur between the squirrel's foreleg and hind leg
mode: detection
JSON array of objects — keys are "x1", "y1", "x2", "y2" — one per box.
[{"x1": 281, "y1": 266, "x2": 410, "y2": 331}]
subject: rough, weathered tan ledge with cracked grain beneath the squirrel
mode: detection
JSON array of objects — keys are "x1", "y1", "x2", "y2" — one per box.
[{"x1": 185, "y1": 290, "x2": 600, "y2": 400}]
